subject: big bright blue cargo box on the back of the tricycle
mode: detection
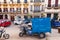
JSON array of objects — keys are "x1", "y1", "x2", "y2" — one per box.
[{"x1": 32, "y1": 18, "x2": 51, "y2": 34}]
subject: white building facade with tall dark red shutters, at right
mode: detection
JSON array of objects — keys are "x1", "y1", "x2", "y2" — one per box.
[{"x1": 45, "y1": 0, "x2": 60, "y2": 20}]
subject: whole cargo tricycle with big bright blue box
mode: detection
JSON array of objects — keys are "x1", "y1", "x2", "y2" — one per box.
[{"x1": 19, "y1": 18, "x2": 51, "y2": 38}]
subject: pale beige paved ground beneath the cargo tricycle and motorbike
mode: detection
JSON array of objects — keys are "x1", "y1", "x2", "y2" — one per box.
[{"x1": 0, "y1": 24, "x2": 60, "y2": 40}]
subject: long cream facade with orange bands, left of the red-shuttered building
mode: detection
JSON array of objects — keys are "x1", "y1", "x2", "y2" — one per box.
[{"x1": 0, "y1": 0, "x2": 45, "y2": 21}]
